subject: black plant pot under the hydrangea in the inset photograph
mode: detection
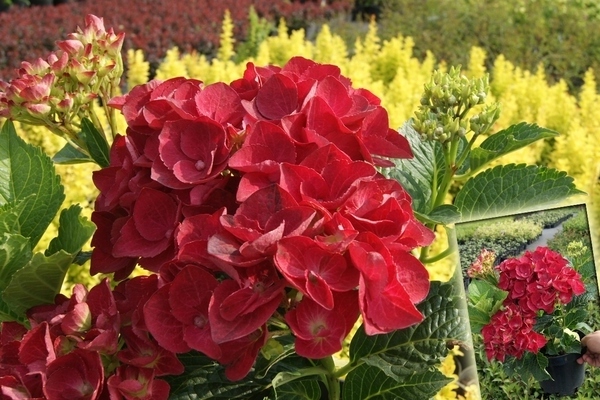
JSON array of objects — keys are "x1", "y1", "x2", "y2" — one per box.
[{"x1": 540, "y1": 353, "x2": 585, "y2": 396}]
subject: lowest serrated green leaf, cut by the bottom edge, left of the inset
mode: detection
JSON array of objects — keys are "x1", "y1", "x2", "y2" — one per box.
[{"x1": 342, "y1": 364, "x2": 450, "y2": 400}]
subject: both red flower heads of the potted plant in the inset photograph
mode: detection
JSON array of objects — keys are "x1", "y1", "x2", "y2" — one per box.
[{"x1": 481, "y1": 247, "x2": 585, "y2": 362}]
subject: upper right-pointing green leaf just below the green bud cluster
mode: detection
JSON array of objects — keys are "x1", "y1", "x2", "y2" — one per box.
[{"x1": 469, "y1": 122, "x2": 558, "y2": 170}]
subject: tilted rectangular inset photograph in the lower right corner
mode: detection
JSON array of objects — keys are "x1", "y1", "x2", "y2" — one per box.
[{"x1": 456, "y1": 204, "x2": 600, "y2": 400}]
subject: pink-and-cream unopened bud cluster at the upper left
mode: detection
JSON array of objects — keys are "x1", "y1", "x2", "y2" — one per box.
[{"x1": 0, "y1": 15, "x2": 124, "y2": 143}]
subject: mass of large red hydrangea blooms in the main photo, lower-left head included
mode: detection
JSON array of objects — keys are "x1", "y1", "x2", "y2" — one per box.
[{"x1": 0, "y1": 57, "x2": 434, "y2": 399}]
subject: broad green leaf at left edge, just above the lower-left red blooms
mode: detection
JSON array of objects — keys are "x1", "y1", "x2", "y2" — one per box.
[{"x1": 2, "y1": 251, "x2": 73, "y2": 314}]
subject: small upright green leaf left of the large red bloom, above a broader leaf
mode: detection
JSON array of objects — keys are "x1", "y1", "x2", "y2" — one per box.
[{"x1": 46, "y1": 205, "x2": 96, "y2": 255}]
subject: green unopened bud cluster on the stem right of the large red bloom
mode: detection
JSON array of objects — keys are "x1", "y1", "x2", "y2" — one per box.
[{"x1": 413, "y1": 64, "x2": 500, "y2": 143}]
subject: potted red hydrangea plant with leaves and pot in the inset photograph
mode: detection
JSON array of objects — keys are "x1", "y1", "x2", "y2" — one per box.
[{"x1": 469, "y1": 246, "x2": 590, "y2": 395}]
